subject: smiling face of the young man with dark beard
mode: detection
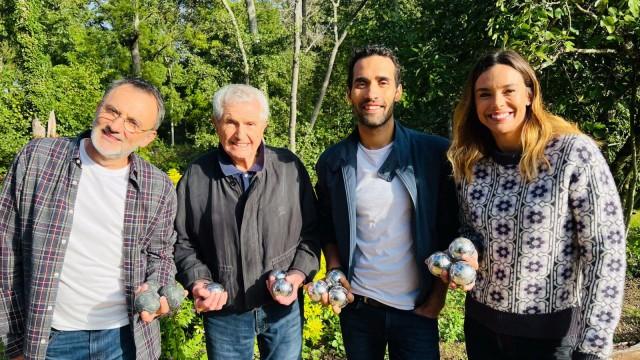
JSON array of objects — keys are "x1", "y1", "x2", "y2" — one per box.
[{"x1": 348, "y1": 55, "x2": 402, "y2": 128}]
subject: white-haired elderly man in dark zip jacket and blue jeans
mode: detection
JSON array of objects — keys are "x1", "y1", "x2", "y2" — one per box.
[{"x1": 175, "y1": 85, "x2": 320, "y2": 360}]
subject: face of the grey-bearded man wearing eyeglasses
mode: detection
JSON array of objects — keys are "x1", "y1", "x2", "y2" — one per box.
[{"x1": 87, "y1": 84, "x2": 158, "y2": 168}]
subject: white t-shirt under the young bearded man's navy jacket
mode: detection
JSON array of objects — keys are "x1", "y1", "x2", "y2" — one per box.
[{"x1": 351, "y1": 143, "x2": 419, "y2": 310}]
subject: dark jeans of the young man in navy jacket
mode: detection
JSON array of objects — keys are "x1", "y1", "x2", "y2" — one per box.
[{"x1": 340, "y1": 300, "x2": 440, "y2": 360}]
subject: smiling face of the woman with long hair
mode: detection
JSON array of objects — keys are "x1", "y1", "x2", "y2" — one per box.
[{"x1": 474, "y1": 64, "x2": 531, "y2": 151}]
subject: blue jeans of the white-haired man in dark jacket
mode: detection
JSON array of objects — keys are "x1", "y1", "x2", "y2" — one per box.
[{"x1": 204, "y1": 301, "x2": 302, "y2": 360}]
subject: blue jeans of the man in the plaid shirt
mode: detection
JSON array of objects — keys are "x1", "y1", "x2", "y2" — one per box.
[{"x1": 46, "y1": 325, "x2": 136, "y2": 360}]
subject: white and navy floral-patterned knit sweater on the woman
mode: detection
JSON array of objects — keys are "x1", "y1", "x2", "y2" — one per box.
[{"x1": 458, "y1": 135, "x2": 625, "y2": 359}]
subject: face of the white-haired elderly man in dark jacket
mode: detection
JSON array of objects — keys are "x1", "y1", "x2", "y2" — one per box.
[{"x1": 213, "y1": 100, "x2": 267, "y2": 171}]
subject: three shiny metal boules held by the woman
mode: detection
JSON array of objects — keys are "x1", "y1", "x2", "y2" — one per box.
[{"x1": 425, "y1": 237, "x2": 477, "y2": 286}]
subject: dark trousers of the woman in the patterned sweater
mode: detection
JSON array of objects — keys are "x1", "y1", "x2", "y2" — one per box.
[{"x1": 464, "y1": 316, "x2": 576, "y2": 360}]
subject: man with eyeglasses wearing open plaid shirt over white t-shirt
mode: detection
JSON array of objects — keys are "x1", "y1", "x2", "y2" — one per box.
[{"x1": 0, "y1": 79, "x2": 176, "y2": 360}]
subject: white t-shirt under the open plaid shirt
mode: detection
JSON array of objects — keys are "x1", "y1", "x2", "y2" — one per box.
[{"x1": 51, "y1": 139, "x2": 129, "y2": 330}]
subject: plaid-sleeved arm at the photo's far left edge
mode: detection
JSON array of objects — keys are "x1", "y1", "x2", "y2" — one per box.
[{"x1": 0, "y1": 149, "x2": 27, "y2": 358}]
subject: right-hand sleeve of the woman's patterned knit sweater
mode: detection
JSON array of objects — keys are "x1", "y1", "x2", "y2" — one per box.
[{"x1": 564, "y1": 139, "x2": 625, "y2": 358}]
